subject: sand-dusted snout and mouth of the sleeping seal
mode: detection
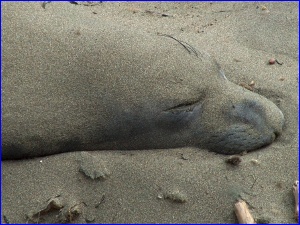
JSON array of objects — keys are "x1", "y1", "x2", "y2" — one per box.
[{"x1": 199, "y1": 95, "x2": 284, "y2": 154}]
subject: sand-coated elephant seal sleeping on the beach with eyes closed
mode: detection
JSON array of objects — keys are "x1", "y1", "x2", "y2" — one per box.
[{"x1": 2, "y1": 3, "x2": 284, "y2": 159}]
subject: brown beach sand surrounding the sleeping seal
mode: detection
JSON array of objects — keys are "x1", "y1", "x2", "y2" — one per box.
[{"x1": 2, "y1": 2, "x2": 298, "y2": 223}]
